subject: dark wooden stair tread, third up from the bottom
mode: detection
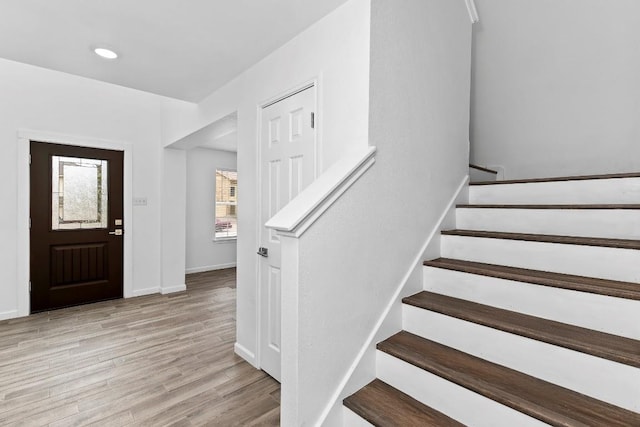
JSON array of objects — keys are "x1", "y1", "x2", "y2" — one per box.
[{"x1": 402, "y1": 291, "x2": 640, "y2": 368}]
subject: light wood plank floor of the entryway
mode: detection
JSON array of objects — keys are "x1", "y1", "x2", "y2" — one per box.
[{"x1": 0, "y1": 269, "x2": 280, "y2": 427}]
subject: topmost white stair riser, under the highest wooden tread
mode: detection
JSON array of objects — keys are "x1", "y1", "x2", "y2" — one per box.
[{"x1": 469, "y1": 178, "x2": 640, "y2": 204}]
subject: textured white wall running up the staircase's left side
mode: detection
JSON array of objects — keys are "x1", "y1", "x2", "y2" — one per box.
[{"x1": 282, "y1": 0, "x2": 471, "y2": 425}]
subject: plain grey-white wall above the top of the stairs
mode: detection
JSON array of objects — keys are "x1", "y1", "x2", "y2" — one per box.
[{"x1": 471, "y1": 0, "x2": 640, "y2": 178}]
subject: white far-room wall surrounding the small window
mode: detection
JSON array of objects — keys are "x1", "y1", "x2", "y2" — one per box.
[{"x1": 186, "y1": 148, "x2": 238, "y2": 273}]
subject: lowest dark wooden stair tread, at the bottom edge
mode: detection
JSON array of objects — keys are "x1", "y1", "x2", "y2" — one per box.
[{"x1": 343, "y1": 379, "x2": 463, "y2": 427}]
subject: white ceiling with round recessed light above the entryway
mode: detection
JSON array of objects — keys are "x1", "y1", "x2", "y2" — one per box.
[{"x1": 0, "y1": 0, "x2": 346, "y2": 102}]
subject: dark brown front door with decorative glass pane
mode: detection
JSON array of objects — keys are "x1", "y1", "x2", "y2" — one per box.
[{"x1": 31, "y1": 142, "x2": 124, "y2": 313}]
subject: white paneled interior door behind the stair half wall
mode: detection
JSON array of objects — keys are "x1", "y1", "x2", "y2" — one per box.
[{"x1": 259, "y1": 87, "x2": 316, "y2": 381}]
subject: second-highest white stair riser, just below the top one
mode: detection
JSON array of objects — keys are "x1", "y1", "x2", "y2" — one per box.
[{"x1": 456, "y1": 210, "x2": 640, "y2": 239}]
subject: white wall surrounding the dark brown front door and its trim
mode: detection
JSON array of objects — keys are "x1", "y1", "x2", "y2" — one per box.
[{"x1": 0, "y1": 56, "x2": 192, "y2": 317}]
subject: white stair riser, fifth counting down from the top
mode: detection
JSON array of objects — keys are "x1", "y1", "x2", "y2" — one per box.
[{"x1": 403, "y1": 305, "x2": 640, "y2": 412}]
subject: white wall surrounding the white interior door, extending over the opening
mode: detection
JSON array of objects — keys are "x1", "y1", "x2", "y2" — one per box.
[{"x1": 163, "y1": 0, "x2": 372, "y2": 363}]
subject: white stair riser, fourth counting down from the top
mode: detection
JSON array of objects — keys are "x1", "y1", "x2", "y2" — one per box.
[{"x1": 423, "y1": 267, "x2": 640, "y2": 340}]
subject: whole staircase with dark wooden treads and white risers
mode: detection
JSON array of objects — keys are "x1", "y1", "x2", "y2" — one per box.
[{"x1": 343, "y1": 174, "x2": 640, "y2": 427}]
